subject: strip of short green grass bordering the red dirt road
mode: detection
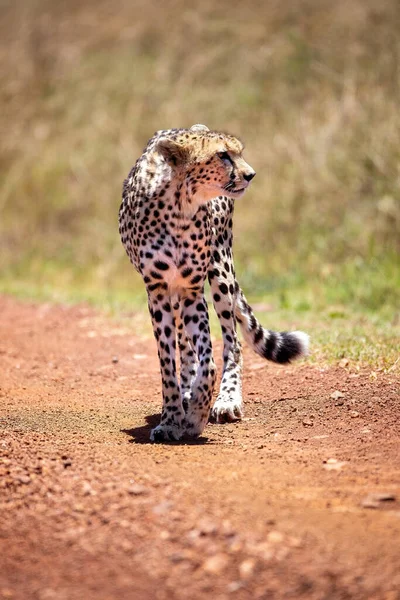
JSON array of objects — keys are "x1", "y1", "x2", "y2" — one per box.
[{"x1": 0, "y1": 262, "x2": 400, "y2": 372}]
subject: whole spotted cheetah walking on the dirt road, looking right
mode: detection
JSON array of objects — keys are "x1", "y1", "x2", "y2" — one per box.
[{"x1": 119, "y1": 125, "x2": 308, "y2": 442}]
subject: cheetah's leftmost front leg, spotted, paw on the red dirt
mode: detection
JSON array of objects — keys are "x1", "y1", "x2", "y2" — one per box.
[{"x1": 148, "y1": 291, "x2": 185, "y2": 442}]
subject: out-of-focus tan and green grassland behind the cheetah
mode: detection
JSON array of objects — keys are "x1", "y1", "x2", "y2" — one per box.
[{"x1": 0, "y1": 0, "x2": 400, "y2": 356}]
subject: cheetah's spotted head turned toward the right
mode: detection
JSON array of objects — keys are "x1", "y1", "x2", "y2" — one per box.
[{"x1": 157, "y1": 125, "x2": 255, "y2": 203}]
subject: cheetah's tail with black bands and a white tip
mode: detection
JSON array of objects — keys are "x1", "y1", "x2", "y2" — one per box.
[{"x1": 235, "y1": 285, "x2": 309, "y2": 364}]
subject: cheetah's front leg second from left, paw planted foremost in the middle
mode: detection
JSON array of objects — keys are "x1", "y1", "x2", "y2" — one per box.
[{"x1": 181, "y1": 290, "x2": 217, "y2": 436}]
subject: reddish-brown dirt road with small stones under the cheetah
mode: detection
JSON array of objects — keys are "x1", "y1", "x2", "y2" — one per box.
[{"x1": 0, "y1": 297, "x2": 400, "y2": 600}]
